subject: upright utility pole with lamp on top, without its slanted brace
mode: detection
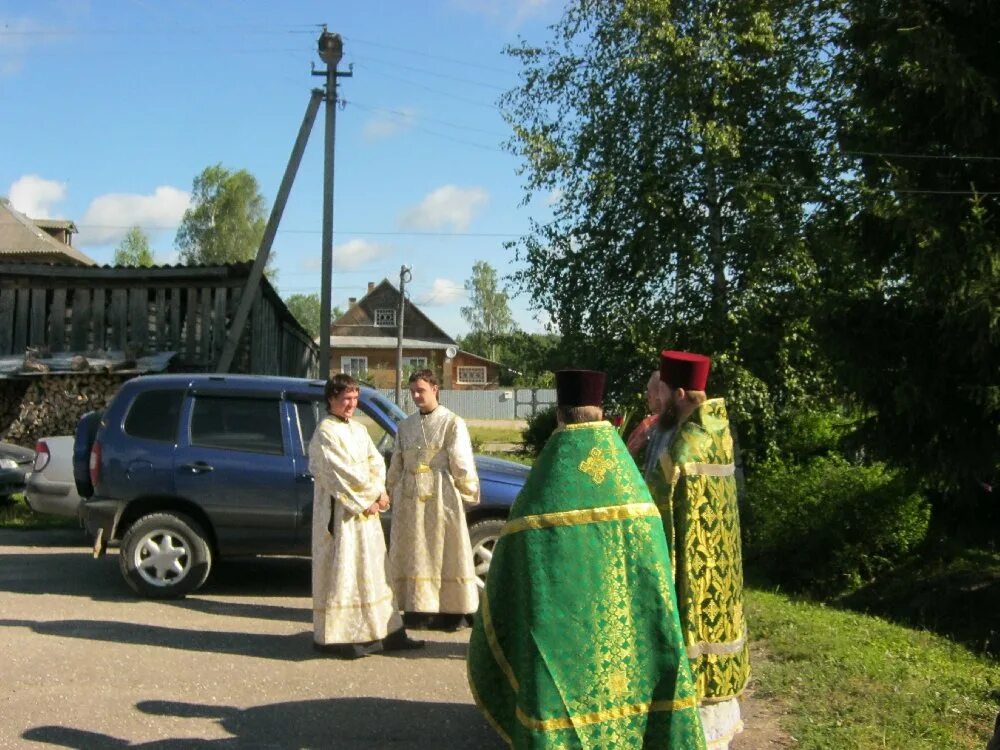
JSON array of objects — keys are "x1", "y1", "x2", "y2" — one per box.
[{"x1": 313, "y1": 24, "x2": 354, "y2": 380}]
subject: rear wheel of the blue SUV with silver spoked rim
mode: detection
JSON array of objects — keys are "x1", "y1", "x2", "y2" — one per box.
[{"x1": 118, "y1": 513, "x2": 212, "y2": 599}]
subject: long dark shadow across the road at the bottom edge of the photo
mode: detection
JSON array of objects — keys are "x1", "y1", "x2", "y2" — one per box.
[{"x1": 21, "y1": 698, "x2": 505, "y2": 750}]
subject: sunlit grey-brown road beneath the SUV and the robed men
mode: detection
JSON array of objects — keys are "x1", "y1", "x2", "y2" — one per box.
[{"x1": 0, "y1": 530, "x2": 787, "y2": 750}]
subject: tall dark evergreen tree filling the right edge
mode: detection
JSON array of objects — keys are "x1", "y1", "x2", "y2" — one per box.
[{"x1": 815, "y1": 0, "x2": 1000, "y2": 530}]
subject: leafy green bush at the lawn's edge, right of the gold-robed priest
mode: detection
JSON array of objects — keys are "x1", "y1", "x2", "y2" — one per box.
[{"x1": 744, "y1": 454, "x2": 930, "y2": 594}]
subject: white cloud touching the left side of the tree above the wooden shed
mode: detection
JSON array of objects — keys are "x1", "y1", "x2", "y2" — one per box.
[{"x1": 77, "y1": 185, "x2": 191, "y2": 247}]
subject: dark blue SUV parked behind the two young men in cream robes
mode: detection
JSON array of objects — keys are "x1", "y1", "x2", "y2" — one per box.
[{"x1": 74, "y1": 375, "x2": 528, "y2": 598}]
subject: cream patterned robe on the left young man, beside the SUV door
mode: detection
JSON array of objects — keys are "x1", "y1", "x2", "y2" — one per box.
[{"x1": 309, "y1": 416, "x2": 403, "y2": 645}]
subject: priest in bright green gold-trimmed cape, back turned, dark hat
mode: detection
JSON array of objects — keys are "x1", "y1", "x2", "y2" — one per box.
[{"x1": 468, "y1": 370, "x2": 705, "y2": 750}]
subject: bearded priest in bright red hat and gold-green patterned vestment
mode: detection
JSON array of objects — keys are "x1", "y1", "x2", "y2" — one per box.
[{"x1": 646, "y1": 351, "x2": 750, "y2": 750}]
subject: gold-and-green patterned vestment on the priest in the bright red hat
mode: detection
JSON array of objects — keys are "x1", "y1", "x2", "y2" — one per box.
[{"x1": 647, "y1": 398, "x2": 750, "y2": 704}]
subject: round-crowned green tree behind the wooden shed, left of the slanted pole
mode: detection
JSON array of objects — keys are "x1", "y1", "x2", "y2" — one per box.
[{"x1": 174, "y1": 164, "x2": 274, "y2": 265}]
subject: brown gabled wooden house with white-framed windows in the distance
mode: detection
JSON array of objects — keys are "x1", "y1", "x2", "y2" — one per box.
[{"x1": 330, "y1": 279, "x2": 502, "y2": 390}]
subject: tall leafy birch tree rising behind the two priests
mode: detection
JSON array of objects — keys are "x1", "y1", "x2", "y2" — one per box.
[{"x1": 502, "y1": 0, "x2": 825, "y2": 470}]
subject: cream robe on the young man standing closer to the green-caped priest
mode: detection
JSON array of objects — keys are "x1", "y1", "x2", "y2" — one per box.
[{"x1": 386, "y1": 405, "x2": 479, "y2": 614}]
